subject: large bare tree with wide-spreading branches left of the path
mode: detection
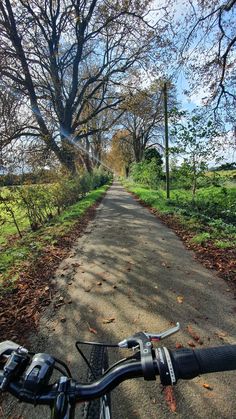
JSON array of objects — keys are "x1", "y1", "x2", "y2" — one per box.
[{"x1": 0, "y1": 0, "x2": 170, "y2": 173}]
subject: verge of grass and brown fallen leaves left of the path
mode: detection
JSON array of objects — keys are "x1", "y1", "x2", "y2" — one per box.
[{"x1": 0, "y1": 185, "x2": 109, "y2": 345}]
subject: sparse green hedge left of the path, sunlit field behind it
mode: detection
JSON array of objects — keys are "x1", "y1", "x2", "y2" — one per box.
[{"x1": 0, "y1": 169, "x2": 111, "y2": 244}]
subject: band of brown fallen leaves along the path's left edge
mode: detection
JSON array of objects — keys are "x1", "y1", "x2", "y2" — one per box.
[{"x1": 0, "y1": 197, "x2": 105, "y2": 344}]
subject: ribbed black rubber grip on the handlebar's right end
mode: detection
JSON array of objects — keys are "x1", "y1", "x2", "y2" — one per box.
[{"x1": 170, "y1": 345, "x2": 236, "y2": 379}]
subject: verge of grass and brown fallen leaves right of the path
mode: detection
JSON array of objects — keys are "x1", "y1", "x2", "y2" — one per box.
[{"x1": 123, "y1": 181, "x2": 236, "y2": 284}]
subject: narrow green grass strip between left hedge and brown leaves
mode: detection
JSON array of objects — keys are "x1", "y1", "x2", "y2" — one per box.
[{"x1": 0, "y1": 185, "x2": 108, "y2": 283}]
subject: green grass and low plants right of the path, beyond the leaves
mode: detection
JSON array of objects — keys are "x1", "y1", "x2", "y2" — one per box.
[{"x1": 123, "y1": 181, "x2": 236, "y2": 249}]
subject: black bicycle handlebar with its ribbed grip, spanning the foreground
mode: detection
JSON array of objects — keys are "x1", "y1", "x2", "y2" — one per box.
[{"x1": 0, "y1": 345, "x2": 236, "y2": 405}]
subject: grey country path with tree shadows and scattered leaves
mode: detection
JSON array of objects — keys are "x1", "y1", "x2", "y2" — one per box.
[{"x1": 4, "y1": 183, "x2": 236, "y2": 419}]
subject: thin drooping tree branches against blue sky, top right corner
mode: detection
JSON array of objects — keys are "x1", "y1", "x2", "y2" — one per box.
[{"x1": 178, "y1": 0, "x2": 236, "y2": 121}]
